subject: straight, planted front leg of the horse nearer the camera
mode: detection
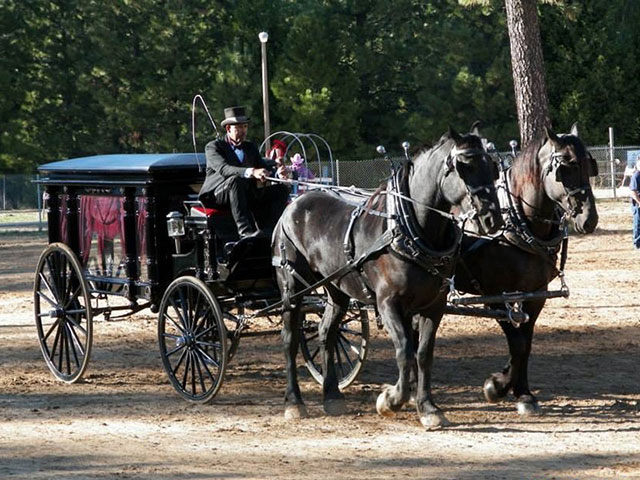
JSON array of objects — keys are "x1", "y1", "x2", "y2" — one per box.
[{"x1": 416, "y1": 316, "x2": 449, "y2": 429}]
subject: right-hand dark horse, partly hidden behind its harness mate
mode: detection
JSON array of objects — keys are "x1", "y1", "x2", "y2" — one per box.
[{"x1": 455, "y1": 124, "x2": 598, "y2": 415}]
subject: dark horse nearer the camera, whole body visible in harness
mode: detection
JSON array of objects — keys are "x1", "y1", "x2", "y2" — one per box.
[{"x1": 273, "y1": 130, "x2": 502, "y2": 427}]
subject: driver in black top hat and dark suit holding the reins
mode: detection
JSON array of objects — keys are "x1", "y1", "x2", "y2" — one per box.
[{"x1": 198, "y1": 107, "x2": 289, "y2": 238}]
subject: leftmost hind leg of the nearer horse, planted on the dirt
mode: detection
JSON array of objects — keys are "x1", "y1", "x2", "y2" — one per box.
[{"x1": 282, "y1": 305, "x2": 307, "y2": 420}]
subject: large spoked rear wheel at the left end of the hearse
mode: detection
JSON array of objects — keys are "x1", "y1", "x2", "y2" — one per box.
[{"x1": 33, "y1": 243, "x2": 93, "y2": 383}]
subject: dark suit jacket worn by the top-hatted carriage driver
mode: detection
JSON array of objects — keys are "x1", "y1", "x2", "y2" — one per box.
[{"x1": 198, "y1": 137, "x2": 268, "y2": 198}]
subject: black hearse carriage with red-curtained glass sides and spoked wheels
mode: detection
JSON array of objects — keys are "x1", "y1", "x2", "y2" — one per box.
[{"x1": 34, "y1": 153, "x2": 368, "y2": 402}]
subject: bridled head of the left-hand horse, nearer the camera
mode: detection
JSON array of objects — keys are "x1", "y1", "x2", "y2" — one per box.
[{"x1": 441, "y1": 127, "x2": 503, "y2": 234}]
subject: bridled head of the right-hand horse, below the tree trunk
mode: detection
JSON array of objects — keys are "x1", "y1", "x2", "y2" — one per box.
[{"x1": 538, "y1": 124, "x2": 598, "y2": 233}]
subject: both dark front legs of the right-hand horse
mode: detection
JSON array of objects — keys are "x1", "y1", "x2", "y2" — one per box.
[{"x1": 484, "y1": 300, "x2": 545, "y2": 415}]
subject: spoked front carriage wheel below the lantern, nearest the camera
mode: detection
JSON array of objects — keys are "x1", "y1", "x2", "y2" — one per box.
[{"x1": 158, "y1": 277, "x2": 227, "y2": 403}]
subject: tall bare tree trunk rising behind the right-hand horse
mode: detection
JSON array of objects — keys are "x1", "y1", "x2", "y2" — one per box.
[{"x1": 505, "y1": 0, "x2": 551, "y2": 147}]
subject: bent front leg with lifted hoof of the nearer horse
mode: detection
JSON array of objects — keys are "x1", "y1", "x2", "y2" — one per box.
[{"x1": 376, "y1": 300, "x2": 415, "y2": 417}]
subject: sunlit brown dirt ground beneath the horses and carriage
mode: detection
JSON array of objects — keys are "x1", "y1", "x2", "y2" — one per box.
[{"x1": 0, "y1": 197, "x2": 640, "y2": 480}]
